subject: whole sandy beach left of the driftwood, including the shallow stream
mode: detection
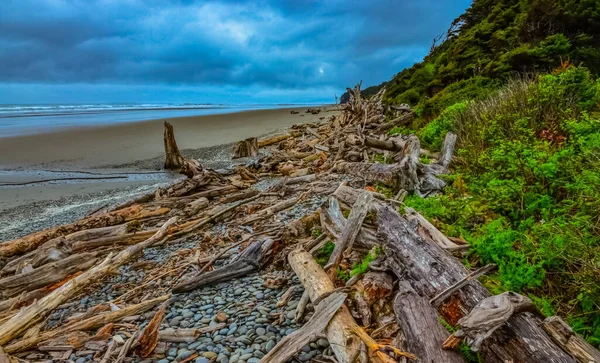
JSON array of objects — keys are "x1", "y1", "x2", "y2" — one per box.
[{"x1": 0, "y1": 107, "x2": 334, "y2": 241}]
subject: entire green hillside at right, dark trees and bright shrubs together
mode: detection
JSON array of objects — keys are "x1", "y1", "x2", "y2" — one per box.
[{"x1": 372, "y1": 0, "x2": 600, "y2": 346}]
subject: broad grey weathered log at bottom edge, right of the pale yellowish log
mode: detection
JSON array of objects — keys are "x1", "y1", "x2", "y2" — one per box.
[{"x1": 394, "y1": 281, "x2": 464, "y2": 363}]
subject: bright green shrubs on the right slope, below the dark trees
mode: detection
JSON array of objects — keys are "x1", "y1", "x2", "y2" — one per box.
[{"x1": 404, "y1": 67, "x2": 600, "y2": 346}]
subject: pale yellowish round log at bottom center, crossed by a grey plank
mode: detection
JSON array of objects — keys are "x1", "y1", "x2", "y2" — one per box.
[{"x1": 288, "y1": 248, "x2": 414, "y2": 363}]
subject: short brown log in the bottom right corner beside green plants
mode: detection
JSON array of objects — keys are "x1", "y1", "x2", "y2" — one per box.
[{"x1": 544, "y1": 316, "x2": 600, "y2": 363}]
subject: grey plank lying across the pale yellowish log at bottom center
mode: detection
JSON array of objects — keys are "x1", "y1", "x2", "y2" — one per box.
[{"x1": 260, "y1": 293, "x2": 347, "y2": 363}]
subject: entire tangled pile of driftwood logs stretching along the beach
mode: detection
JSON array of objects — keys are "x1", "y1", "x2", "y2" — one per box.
[{"x1": 0, "y1": 87, "x2": 599, "y2": 363}]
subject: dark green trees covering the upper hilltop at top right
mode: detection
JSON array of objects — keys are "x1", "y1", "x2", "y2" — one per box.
[{"x1": 384, "y1": 0, "x2": 600, "y2": 119}]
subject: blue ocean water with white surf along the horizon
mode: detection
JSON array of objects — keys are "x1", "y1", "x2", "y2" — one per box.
[{"x1": 0, "y1": 103, "x2": 310, "y2": 138}]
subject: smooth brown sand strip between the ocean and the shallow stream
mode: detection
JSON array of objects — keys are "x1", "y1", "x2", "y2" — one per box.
[{"x1": 0, "y1": 108, "x2": 331, "y2": 170}]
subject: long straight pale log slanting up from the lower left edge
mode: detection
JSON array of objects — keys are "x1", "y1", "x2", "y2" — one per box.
[{"x1": 0, "y1": 217, "x2": 177, "y2": 345}]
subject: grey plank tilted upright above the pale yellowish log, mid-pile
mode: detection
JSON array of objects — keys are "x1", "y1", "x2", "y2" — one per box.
[{"x1": 326, "y1": 192, "x2": 373, "y2": 269}]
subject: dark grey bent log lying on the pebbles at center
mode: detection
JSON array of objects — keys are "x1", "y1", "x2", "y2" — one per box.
[{"x1": 173, "y1": 238, "x2": 273, "y2": 293}]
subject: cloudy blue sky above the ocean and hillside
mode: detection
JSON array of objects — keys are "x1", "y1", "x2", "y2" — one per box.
[{"x1": 0, "y1": 0, "x2": 471, "y2": 104}]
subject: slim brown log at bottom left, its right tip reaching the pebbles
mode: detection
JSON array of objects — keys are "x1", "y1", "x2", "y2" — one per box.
[{"x1": 5, "y1": 295, "x2": 170, "y2": 353}]
